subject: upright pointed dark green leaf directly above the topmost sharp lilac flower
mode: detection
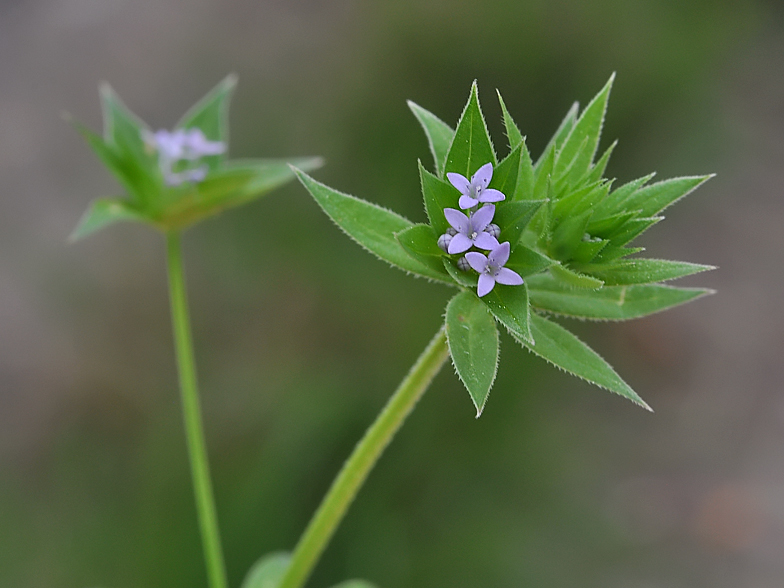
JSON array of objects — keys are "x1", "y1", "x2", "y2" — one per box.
[{"x1": 444, "y1": 81, "x2": 496, "y2": 179}]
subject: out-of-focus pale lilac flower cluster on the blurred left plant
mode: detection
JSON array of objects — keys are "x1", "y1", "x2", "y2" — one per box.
[{"x1": 142, "y1": 127, "x2": 226, "y2": 186}]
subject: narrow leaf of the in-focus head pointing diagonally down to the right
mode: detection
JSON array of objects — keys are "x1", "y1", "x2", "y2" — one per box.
[{"x1": 513, "y1": 313, "x2": 651, "y2": 410}]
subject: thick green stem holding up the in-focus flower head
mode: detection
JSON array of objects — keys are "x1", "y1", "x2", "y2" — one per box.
[{"x1": 279, "y1": 327, "x2": 449, "y2": 588}]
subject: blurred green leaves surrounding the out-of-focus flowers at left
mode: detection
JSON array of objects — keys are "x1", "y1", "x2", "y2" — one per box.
[{"x1": 71, "y1": 76, "x2": 321, "y2": 239}]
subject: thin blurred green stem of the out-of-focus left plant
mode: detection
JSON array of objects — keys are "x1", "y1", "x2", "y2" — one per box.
[{"x1": 166, "y1": 231, "x2": 228, "y2": 588}]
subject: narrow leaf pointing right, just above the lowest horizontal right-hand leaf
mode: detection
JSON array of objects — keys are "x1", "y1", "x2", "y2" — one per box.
[{"x1": 576, "y1": 258, "x2": 716, "y2": 286}]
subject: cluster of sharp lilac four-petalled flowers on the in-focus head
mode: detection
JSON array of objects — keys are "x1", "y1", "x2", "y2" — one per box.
[{"x1": 438, "y1": 163, "x2": 523, "y2": 297}]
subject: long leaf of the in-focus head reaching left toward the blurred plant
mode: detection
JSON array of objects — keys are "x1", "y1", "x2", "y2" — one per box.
[{"x1": 295, "y1": 170, "x2": 452, "y2": 284}]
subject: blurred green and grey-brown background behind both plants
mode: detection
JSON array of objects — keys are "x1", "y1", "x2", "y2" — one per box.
[{"x1": 0, "y1": 0, "x2": 784, "y2": 588}]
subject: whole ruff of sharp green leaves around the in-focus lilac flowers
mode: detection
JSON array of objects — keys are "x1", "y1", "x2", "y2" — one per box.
[{"x1": 297, "y1": 76, "x2": 713, "y2": 416}]
